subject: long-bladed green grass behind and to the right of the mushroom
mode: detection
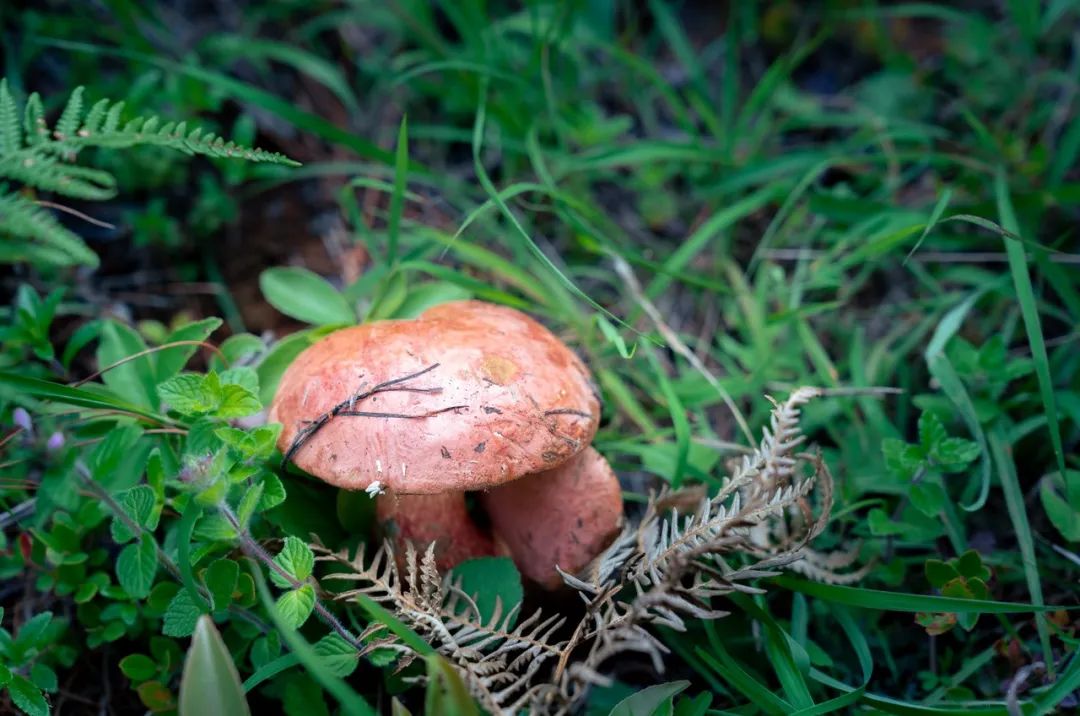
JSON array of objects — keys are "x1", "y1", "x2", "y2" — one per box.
[{"x1": 0, "y1": 0, "x2": 1080, "y2": 715}]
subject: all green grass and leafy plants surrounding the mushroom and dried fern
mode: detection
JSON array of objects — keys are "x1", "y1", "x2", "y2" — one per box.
[{"x1": 0, "y1": 0, "x2": 1080, "y2": 715}]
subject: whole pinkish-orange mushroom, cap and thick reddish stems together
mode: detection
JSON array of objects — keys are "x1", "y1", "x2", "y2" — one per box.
[{"x1": 269, "y1": 301, "x2": 622, "y2": 586}]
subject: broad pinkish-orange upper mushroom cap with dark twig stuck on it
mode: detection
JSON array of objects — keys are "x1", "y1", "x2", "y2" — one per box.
[{"x1": 269, "y1": 301, "x2": 599, "y2": 494}]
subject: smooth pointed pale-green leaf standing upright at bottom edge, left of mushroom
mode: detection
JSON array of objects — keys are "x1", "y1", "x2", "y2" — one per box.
[{"x1": 179, "y1": 614, "x2": 251, "y2": 716}]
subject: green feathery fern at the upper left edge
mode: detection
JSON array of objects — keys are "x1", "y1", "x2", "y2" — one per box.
[{"x1": 0, "y1": 79, "x2": 297, "y2": 266}]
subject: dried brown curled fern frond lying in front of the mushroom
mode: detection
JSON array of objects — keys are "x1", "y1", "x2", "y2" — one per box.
[{"x1": 316, "y1": 388, "x2": 859, "y2": 714}]
